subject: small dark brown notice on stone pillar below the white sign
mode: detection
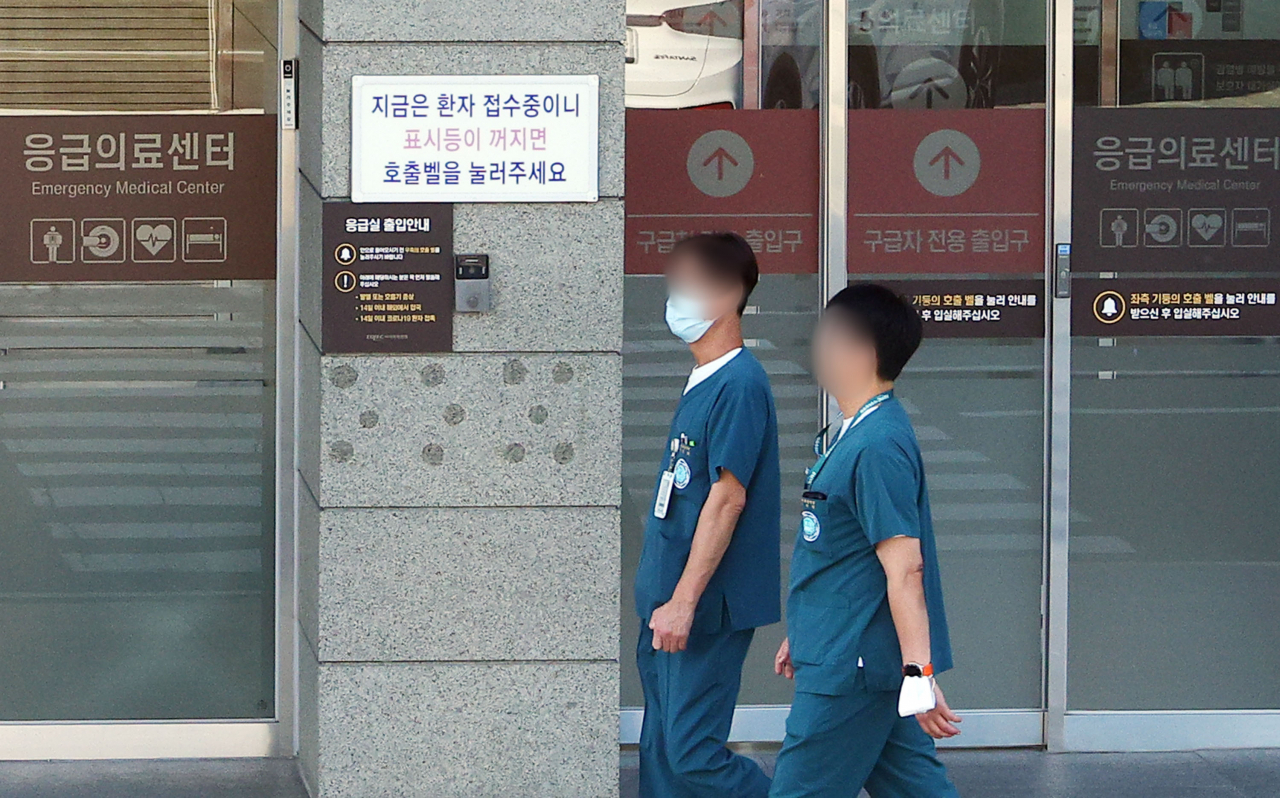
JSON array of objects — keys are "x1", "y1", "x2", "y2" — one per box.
[{"x1": 321, "y1": 202, "x2": 453, "y2": 355}]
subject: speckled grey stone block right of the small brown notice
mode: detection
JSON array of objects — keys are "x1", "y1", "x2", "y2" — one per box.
[{"x1": 453, "y1": 200, "x2": 626, "y2": 352}]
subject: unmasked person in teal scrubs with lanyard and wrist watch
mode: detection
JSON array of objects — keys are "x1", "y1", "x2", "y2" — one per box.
[{"x1": 769, "y1": 284, "x2": 960, "y2": 798}]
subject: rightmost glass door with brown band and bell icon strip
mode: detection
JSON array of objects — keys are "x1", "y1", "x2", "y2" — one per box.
[{"x1": 1055, "y1": 0, "x2": 1280, "y2": 751}]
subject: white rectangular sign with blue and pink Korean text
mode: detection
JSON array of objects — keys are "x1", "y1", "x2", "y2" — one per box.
[{"x1": 351, "y1": 74, "x2": 600, "y2": 202}]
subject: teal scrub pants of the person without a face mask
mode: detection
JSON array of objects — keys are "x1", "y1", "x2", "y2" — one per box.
[{"x1": 769, "y1": 675, "x2": 960, "y2": 798}]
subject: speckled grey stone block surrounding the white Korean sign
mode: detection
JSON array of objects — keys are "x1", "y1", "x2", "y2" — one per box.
[{"x1": 298, "y1": 37, "x2": 626, "y2": 201}]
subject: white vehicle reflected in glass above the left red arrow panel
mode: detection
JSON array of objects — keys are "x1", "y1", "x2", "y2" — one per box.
[{"x1": 626, "y1": 0, "x2": 742, "y2": 108}]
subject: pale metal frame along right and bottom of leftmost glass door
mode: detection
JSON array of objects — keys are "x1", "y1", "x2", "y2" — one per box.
[{"x1": 0, "y1": 0, "x2": 300, "y2": 761}]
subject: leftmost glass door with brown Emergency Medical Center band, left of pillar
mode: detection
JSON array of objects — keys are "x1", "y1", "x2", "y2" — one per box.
[{"x1": 0, "y1": 0, "x2": 279, "y2": 758}]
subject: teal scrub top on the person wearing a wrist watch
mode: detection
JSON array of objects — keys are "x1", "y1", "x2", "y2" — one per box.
[{"x1": 787, "y1": 398, "x2": 951, "y2": 696}]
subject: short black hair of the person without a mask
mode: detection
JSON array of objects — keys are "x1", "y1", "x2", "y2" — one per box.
[{"x1": 827, "y1": 283, "x2": 924, "y2": 380}]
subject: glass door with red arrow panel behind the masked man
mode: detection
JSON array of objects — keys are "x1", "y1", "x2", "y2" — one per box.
[{"x1": 620, "y1": 0, "x2": 823, "y2": 743}]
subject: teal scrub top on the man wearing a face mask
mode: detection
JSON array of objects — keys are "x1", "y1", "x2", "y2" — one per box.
[{"x1": 636, "y1": 350, "x2": 782, "y2": 634}]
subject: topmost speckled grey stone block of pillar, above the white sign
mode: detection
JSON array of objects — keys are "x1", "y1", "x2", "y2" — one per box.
[{"x1": 300, "y1": 0, "x2": 626, "y2": 42}]
